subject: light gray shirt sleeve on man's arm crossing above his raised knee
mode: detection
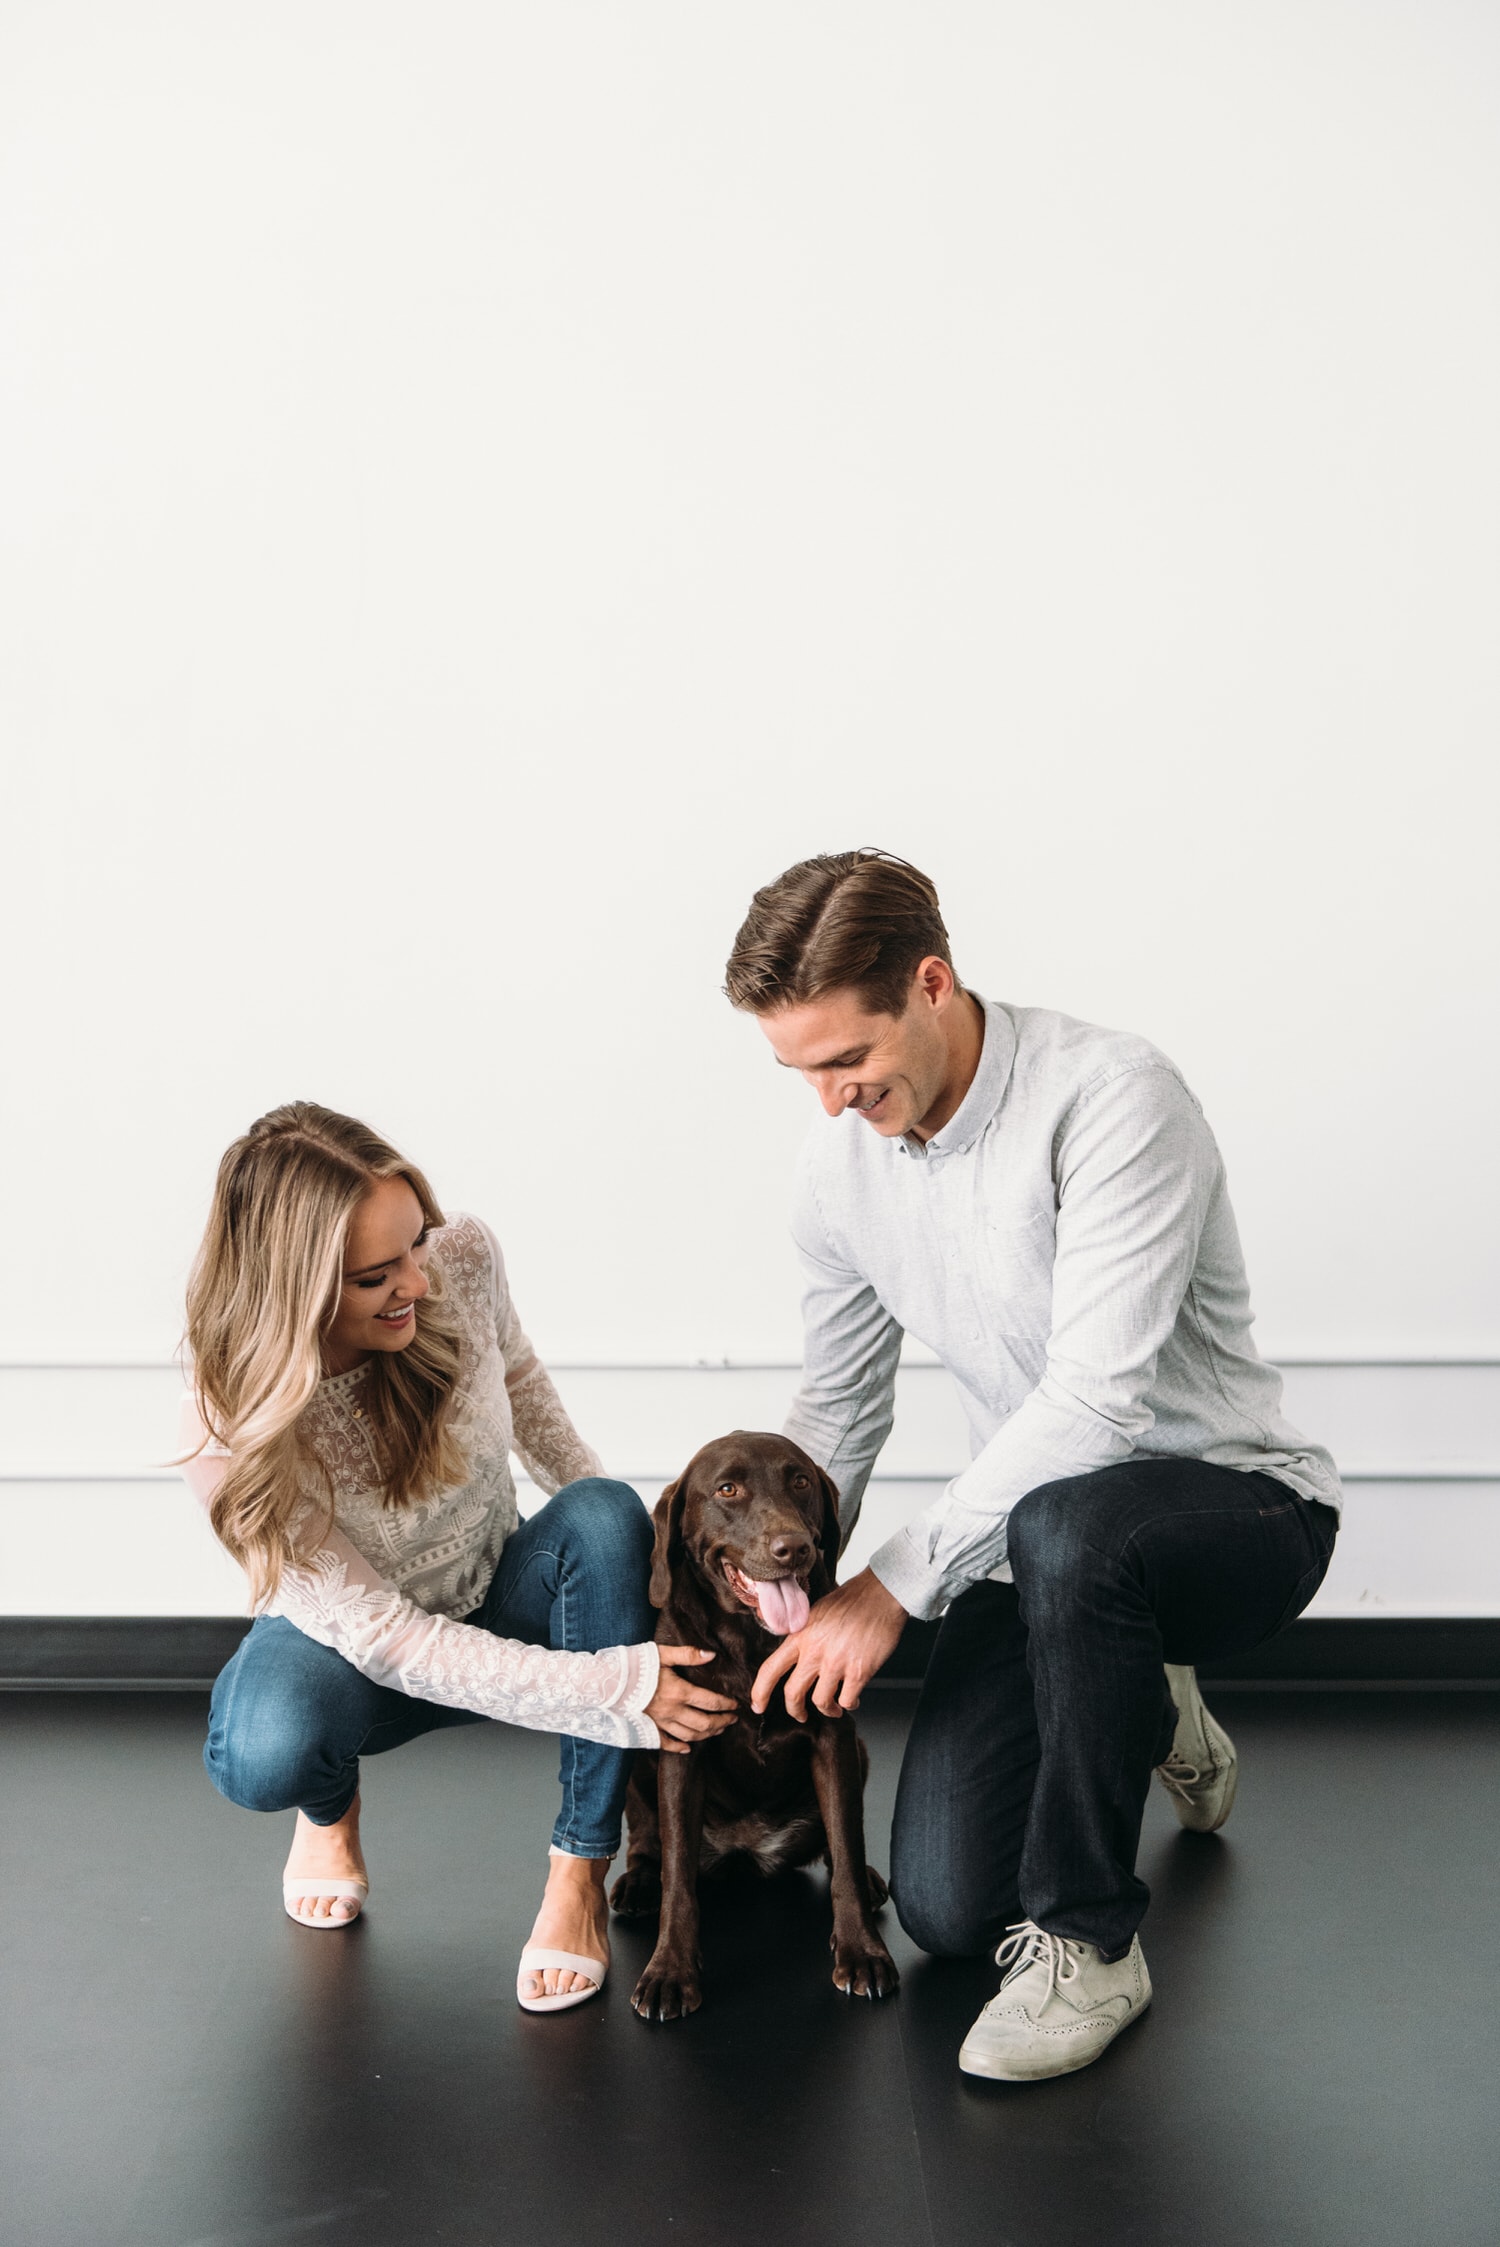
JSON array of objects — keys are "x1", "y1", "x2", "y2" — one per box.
[{"x1": 871, "y1": 1065, "x2": 1222, "y2": 1616}]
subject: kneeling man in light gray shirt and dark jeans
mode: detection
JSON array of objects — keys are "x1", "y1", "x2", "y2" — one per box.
[{"x1": 728, "y1": 849, "x2": 1341, "y2": 2081}]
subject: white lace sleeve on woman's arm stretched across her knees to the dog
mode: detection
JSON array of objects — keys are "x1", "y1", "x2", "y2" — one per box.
[{"x1": 274, "y1": 1530, "x2": 660, "y2": 1748}]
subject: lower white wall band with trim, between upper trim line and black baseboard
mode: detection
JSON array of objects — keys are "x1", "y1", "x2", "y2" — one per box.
[{"x1": 0, "y1": 1357, "x2": 1500, "y2": 1616}]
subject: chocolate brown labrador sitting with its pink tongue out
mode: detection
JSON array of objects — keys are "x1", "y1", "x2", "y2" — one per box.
[{"x1": 611, "y1": 1429, "x2": 898, "y2": 2020}]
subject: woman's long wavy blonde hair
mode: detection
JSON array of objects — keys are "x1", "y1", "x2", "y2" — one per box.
[{"x1": 186, "y1": 1101, "x2": 467, "y2": 1609}]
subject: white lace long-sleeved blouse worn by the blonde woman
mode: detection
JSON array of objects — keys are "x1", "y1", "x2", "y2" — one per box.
[{"x1": 182, "y1": 1216, "x2": 660, "y2": 1748}]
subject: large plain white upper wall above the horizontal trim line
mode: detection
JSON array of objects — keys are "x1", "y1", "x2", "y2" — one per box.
[{"x1": 0, "y1": 0, "x2": 1500, "y2": 1598}]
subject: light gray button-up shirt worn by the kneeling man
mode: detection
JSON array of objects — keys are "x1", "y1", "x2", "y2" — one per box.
[{"x1": 786, "y1": 993, "x2": 1343, "y2": 1616}]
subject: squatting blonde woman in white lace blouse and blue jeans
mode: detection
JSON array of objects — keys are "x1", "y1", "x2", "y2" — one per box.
[{"x1": 184, "y1": 1101, "x2": 734, "y2": 2011}]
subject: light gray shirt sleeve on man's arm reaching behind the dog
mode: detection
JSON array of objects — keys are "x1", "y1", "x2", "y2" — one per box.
[{"x1": 781, "y1": 1162, "x2": 900, "y2": 1544}]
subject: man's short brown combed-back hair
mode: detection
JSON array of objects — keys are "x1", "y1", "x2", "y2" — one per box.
[{"x1": 723, "y1": 849, "x2": 952, "y2": 1013}]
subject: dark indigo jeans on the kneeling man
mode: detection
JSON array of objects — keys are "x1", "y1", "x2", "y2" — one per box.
[{"x1": 891, "y1": 1458, "x2": 1338, "y2": 1959}]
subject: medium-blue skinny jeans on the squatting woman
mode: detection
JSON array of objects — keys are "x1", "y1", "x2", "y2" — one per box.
[{"x1": 204, "y1": 1476, "x2": 656, "y2": 1856}]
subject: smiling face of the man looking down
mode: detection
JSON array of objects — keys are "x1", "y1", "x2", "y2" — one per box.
[{"x1": 757, "y1": 959, "x2": 954, "y2": 1139}]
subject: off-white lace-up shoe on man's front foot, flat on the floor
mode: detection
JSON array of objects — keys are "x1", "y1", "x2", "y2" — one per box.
[{"x1": 959, "y1": 1919, "x2": 1152, "y2": 2083}]
